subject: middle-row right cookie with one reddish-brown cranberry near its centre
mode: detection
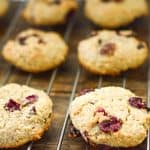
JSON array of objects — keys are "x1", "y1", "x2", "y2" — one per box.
[{"x1": 78, "y1": 30, "x2": 148, "y2": 75}]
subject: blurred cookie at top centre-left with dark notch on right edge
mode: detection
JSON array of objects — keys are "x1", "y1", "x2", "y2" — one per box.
[{"x1": 23, "y1": 0, "x2": 78, "y2": 25}]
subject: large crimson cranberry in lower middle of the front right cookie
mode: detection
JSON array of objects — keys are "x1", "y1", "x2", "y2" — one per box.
[{"x1": 99, "y1": 116, "x2": 122, "y2": 133}]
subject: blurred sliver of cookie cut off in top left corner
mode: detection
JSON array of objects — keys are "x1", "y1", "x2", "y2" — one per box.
[{"x1": 0, "y1": 0, "x2": 9, "y2": 17}]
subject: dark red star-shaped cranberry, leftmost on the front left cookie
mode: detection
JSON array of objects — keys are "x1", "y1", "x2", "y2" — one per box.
[{"x1": 4, "y1": 99, "x2": 20, "y2": 112}]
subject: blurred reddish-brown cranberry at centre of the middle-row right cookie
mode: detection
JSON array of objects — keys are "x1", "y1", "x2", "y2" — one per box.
[{"x1": 100, "y1": 43, "x2": 116, "y2": 56}]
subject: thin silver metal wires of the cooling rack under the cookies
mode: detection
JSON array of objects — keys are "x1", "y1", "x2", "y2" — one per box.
[{"x1": 0, "y1": 0, "x2": 150, "y2": 150}]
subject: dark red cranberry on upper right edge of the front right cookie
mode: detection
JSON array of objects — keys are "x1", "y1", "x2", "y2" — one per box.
[{"x1": 129, "y1": 97, "x2": 146, "y2": 109}]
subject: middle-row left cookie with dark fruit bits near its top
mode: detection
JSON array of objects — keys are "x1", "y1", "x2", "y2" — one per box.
[{"x1": 2, "y1": 29, "x2": 68, "y2": 73}]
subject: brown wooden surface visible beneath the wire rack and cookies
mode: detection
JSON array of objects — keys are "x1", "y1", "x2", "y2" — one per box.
[{"x1": 0, "y1": 2, "x2": 149, "y2": 150}]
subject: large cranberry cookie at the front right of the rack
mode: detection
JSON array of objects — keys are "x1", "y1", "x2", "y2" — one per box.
[{"x1": 70, "y1": 87, "x2": 150, "y2": 147}]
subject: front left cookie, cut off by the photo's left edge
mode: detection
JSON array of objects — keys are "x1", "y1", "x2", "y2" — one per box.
[{"x1": 0, "y1": 83, "x2": 52, "y2": 148}]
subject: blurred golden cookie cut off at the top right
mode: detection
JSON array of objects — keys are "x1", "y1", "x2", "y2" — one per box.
[{"x1": 85, "y1": 0, "x2": 148, "y2": 28}]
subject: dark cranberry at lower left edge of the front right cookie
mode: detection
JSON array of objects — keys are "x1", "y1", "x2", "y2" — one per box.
[{"x1": 69, "y1": 123, "x2": 81, "y2": 138}]
